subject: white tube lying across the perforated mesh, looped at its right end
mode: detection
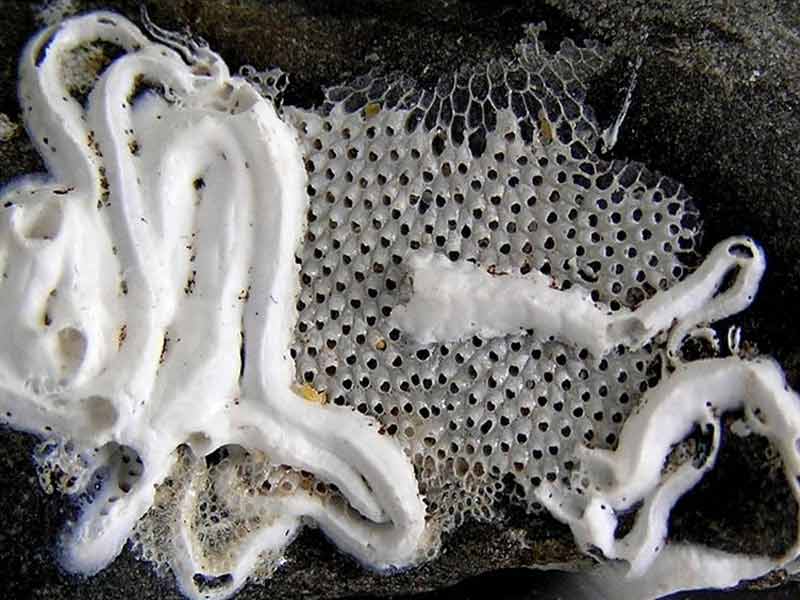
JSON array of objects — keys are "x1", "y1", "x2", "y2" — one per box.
[{"x1": 393, "y1": 238, "x2": 765, "y2": 358}]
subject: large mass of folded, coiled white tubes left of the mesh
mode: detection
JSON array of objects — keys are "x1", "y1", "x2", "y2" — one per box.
[{"x1": 0, "y1": 13, "x2": 425, "y2": 596}]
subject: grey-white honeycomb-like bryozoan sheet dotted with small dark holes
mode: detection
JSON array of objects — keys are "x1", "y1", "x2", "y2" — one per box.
[{"x1": 287, "y1": 31, "x2": 697, "y2": 527}]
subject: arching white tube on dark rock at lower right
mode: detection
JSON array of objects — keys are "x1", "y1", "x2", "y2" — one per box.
[{"x1": 571, "y1": 358, "x2": 800, "y2": 576}]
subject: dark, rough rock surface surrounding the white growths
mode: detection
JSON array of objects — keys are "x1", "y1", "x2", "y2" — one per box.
[{"x1": 0, "y1": 0, "x2": 800, "y2": 600}]
